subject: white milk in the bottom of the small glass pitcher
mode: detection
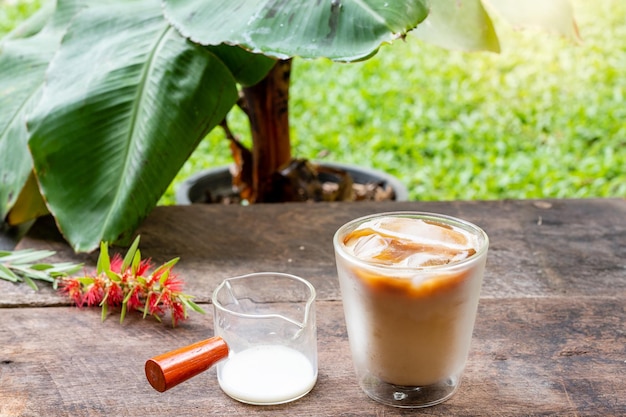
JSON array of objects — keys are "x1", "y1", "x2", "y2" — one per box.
[{"x1": 218, "y1": 345, "x2": 317, "y2": 404}]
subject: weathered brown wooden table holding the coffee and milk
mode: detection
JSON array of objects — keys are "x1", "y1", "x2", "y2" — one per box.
[{"x1": 0, "y1": 199, "x2": 626, "y2": 417}]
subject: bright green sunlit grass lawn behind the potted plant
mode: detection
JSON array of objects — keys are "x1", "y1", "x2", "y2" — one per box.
[{"x1": 0, "y1": 0, "x2": 626, "y2": 204}]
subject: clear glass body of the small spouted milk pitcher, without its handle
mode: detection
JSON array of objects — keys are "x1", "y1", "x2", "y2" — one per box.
[{"x1": 212, "y1": 272, "x2": 317, "y2": 405}]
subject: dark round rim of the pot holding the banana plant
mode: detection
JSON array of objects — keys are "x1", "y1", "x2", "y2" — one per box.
[{"x1": 176, "y1": 162, "x2": 409, "y2": 205}]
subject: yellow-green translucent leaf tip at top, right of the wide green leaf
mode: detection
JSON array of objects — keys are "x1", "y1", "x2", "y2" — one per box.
[{"x1": 411, "y1": 0, "x2": 500, "y2": 52}]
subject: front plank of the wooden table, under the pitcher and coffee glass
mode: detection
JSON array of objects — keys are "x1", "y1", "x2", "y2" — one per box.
[{"x1": 0, "y1": 297, "x2": 626, "y2": 416}]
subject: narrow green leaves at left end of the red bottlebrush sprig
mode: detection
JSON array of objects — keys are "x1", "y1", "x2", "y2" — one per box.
[{"x1": 0, "y1": 249, "x2": 83, "y2": 291}]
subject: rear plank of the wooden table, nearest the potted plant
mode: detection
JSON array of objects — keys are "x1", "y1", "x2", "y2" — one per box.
[{"x1": 7, "y1": 199, "x2": 626, "y2": 307}]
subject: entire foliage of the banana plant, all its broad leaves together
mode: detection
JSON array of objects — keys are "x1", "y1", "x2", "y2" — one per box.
[{"x1": 0, "y1": 0, "x2": 578, "y2": 251}]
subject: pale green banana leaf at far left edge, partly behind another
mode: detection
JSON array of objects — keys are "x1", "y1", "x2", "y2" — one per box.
[{"x1": 0, "y1": 0, "x2": 95, "y2": 221}]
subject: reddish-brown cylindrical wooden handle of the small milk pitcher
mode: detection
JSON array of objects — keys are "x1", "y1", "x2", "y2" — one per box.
[{"x1": 146, "y1": 336, "x2": 228, "y2": 392}]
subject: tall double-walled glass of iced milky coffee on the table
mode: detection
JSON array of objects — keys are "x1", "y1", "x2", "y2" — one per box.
[{"x1": 333, "y1": 212, "x2": 489, "y2": 408}]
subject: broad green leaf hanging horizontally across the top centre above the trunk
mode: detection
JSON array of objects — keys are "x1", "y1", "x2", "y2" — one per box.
[{"x1": 164, "y1": 0, "x2": 428, "y2": 61}]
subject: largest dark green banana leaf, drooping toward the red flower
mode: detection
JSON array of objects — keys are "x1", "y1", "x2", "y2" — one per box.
[{"x1": 29, "y1": 0, "x2": 237, "y2": 251}]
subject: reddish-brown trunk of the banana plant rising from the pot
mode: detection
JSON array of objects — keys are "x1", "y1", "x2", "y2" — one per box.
[{"x1": 243, "y1": 59, "x2": 291, "y2": 203}]
